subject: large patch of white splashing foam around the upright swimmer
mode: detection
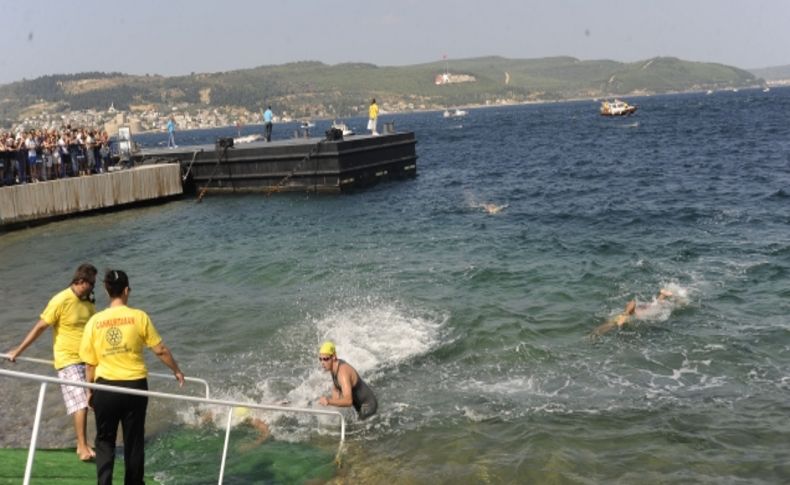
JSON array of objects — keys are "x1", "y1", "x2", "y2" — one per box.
[{"x1": 169, "y1": 298, "x2": 448, "y2": 441}]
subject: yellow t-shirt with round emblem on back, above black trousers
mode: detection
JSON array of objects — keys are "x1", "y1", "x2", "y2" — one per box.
[{"x1": 80, "y1": 305, "x2": 162, "y2": 381}]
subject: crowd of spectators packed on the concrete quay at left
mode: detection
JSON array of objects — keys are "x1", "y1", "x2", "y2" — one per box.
[{"x1": 0, "y1": 125, "x2": 112, "y2": 186}]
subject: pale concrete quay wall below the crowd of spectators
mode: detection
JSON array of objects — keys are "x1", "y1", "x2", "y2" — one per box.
[{"x1": 0, "y1": 164, "x2": 183, "y2": 231}]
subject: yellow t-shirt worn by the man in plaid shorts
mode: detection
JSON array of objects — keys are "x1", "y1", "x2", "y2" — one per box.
[{"x1": 39, "y1": 287, "x2": 96, "y2": 369}]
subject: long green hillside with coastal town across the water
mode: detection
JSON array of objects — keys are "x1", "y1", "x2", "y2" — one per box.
[{"x1": 0, "y1": 57, "x2": 762, "y2": 125}]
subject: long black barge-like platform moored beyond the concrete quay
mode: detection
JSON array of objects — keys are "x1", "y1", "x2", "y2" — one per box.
[{"x1": 132, "y1": 130, "x2": 417, "y2": 195}]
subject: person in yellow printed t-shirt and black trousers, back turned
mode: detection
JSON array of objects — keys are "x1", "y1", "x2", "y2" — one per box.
[{"x1": 80, "y1": 270, "x2": 184, "y2": 485}]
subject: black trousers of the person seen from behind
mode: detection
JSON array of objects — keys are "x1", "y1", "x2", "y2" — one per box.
[{"x1": 93, "y1": 378, "x2": 148, "y2": 485}]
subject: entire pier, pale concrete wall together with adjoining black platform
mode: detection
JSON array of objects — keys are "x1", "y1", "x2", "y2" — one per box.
[{"x1": 0, "y1": 127, "x2": 417, "y2": 232}]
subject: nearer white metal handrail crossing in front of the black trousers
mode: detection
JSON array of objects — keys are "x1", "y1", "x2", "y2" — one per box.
[{"x1": 0, "y1": 369, "x2": 346, "y2": 485}]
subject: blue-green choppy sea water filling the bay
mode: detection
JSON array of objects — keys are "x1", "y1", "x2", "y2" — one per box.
[{"x1": 0, "y1": 89, "x2": 790, "y2": 484}]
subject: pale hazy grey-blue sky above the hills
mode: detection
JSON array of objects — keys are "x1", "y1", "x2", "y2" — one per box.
[{"x1": 0, "y1": 0, "x2": 790, "y2": 84}]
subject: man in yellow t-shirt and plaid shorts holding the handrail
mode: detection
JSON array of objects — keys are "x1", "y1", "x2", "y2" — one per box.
[{"x1": 8, "y1": 263, "x2": 97, "y2": 461}]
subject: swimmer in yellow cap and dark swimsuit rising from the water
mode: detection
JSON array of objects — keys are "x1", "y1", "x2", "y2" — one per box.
[{"x1": 318, "y1": 340, "x2": 378, "y2": 419}]
